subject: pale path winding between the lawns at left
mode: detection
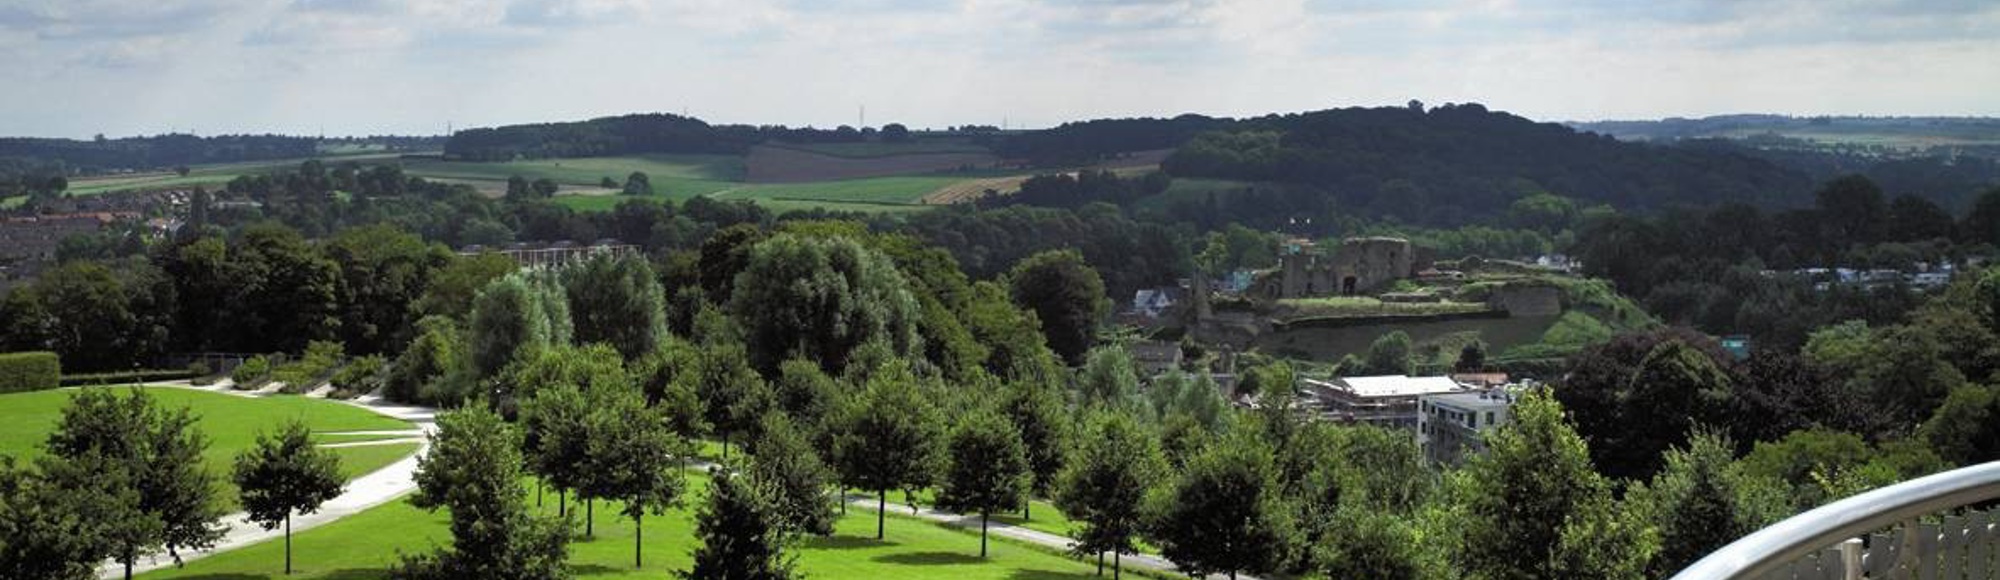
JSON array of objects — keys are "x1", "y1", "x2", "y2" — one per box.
[{"x1": 98, "y1": 380, "x2": 438, "y2": 578}]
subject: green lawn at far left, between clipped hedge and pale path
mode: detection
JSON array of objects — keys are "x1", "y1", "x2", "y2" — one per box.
[{"x1": 0, "y1": 388, "x2": 416, "y2": 506}]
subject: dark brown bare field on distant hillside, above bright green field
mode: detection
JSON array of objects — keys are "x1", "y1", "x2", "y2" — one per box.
[{"x1": 744, "y1": 146, "x2": 1000, "y2": 184}]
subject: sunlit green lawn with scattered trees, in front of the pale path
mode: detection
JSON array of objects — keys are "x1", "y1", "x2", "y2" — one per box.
[{"x1": 140, "y1": 474, "x2": 1136, "y2": 580}]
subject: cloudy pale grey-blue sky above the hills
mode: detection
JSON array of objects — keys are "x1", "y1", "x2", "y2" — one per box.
[{"x1": 0, "y1": 0, "x2": 2000, "y2": 138}]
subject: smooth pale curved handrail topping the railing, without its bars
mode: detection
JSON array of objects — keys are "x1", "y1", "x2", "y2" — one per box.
[{"x1": 1674, "y1": 462, "x2": 2000, "y2": 580}]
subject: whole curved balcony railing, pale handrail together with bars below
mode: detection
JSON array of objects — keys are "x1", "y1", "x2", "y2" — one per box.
[{"x1": 1674, "y1": 462, "x2": 2000, "y2": 580}]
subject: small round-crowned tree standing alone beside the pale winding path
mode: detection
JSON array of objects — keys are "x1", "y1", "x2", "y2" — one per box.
[{"x1": 234, "y1": 420, "x2": 344, "y2": 574}]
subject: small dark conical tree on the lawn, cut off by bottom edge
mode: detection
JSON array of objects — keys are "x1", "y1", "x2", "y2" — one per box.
[{"x1": 680, "y1": 468, "x2": 798, "y2": 580}]
